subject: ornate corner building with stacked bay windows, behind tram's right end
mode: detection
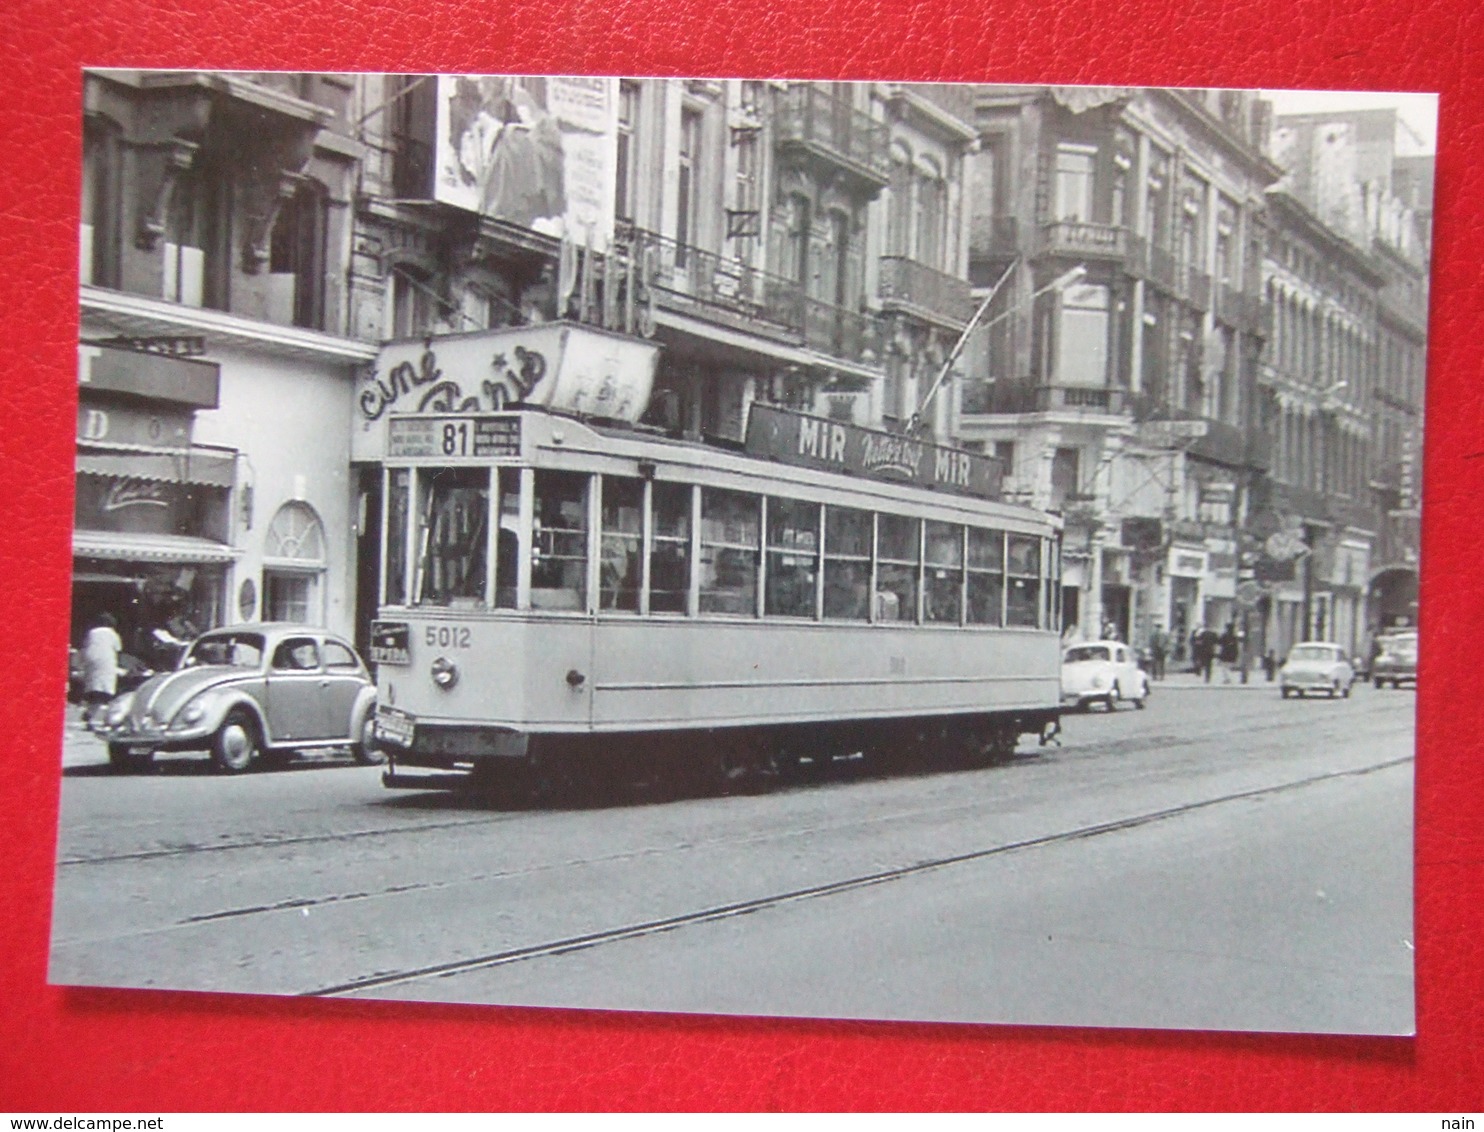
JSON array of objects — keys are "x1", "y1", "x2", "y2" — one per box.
[{"x1": 960, "y1": 88, "x2": 1281, "y2": 659}]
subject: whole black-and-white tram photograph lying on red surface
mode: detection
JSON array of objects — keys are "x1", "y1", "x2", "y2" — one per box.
[{"x1": 49, "y1": 70, "x2": 1438, "y2": 1036}]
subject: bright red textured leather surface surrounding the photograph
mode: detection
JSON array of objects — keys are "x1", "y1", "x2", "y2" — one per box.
[{"x1": 0, "y1": 0, "x2": 1484, "y2": 1111}]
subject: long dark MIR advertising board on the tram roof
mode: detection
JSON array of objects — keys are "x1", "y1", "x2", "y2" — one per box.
[{"x1": 746, "y1": 402, "x2": 1002, "y2": 498}]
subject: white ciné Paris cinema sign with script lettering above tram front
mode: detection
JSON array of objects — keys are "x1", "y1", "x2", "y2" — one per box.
[{"x1": 355, "y1": 322, "x2": 659, "y2": 460}]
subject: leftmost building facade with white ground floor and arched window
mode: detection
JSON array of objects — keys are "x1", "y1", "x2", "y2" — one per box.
[{"x1": 73, "y1": 71, "x2": 375, "y2": 662}]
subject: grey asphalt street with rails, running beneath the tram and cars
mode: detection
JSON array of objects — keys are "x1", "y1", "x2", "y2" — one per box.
[{"x1": 50, "y1": 685, "x2": 1416, "y2": 1034}]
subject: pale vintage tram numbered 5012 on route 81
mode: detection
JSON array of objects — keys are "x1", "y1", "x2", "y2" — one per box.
[{"x1": 368, "y1": 385, "x2": 1061, "y2": 786}]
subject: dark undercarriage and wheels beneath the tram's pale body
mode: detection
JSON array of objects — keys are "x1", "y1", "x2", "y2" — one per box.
[{"x1": 383, "y1": 708, "x2": 1061, "y2": 800}]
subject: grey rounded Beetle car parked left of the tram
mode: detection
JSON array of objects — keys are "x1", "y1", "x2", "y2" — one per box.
[{"x1": 96, "y1": 622, "x2": 384, "y2": 773}]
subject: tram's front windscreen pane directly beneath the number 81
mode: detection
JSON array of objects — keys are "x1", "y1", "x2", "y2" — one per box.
[{"x1": 417, "y1": 467, "x2": 490, "y2": 605}]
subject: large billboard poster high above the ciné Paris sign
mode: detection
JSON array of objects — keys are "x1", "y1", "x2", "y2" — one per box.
[{"x1": 433, "y1": 74, "x2": 619, "y2": 251}]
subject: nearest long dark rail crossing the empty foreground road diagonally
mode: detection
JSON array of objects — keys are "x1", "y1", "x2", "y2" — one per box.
[{"x1": 307, "y1": 755, "x2": 1414, "y2": 997}]
